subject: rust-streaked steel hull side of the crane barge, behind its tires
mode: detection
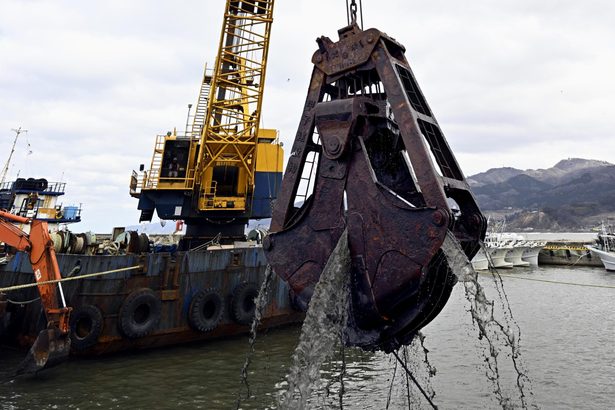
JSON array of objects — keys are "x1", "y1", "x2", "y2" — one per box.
[{"x1": 0, "y1": 246, "x2": 304, "y2": 355}]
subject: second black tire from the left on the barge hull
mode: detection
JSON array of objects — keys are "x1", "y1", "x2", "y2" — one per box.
[{"x1": 117, "y1": 288, "x2": 162, "y2": 339}]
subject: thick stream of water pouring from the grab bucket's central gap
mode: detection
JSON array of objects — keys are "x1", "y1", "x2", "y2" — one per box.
[{"x1": 278, "y1": 231, "x2": 350, "y2": 410}]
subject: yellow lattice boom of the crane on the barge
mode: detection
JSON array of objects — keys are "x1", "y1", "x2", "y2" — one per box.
[{"x1": 196, "y1": 0, "x2": 274, "y2": 210}]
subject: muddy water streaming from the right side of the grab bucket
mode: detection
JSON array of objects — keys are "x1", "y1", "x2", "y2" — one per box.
[{"x1": 442, "y1": 232, "x2": 536, "y2": 409}]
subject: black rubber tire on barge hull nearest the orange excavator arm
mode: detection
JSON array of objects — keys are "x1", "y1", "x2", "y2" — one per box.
[{"x1": 69, "y1": 305, "x2": 104, "y2": 351}]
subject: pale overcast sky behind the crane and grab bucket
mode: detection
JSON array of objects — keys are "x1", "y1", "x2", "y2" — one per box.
[{"x1": 0, "y1": 0, "x2": 615, "y2": 232}]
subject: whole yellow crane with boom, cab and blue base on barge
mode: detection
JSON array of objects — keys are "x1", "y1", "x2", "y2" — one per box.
[{"x1": 130, "y1": 0, "x2": 283, "y2": 245}]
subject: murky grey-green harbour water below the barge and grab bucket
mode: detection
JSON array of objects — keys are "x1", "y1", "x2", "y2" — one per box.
[{"x1": 0, "y1": 267, "x2": 615, "y2": 410}]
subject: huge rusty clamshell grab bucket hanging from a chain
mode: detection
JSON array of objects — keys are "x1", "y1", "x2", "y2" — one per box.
[{"x1": 263, "y1": 25, "x2": 486, "y2": 351}]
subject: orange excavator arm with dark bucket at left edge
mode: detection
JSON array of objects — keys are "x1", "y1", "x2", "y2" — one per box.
[{"x1": 0, "y1": 211, "x2": 71, "y2": 373}]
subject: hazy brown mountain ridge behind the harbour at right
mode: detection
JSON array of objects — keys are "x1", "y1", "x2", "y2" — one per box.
[{"x1": 467, "y1": 158, "x2": 615, "y2": 230}]
